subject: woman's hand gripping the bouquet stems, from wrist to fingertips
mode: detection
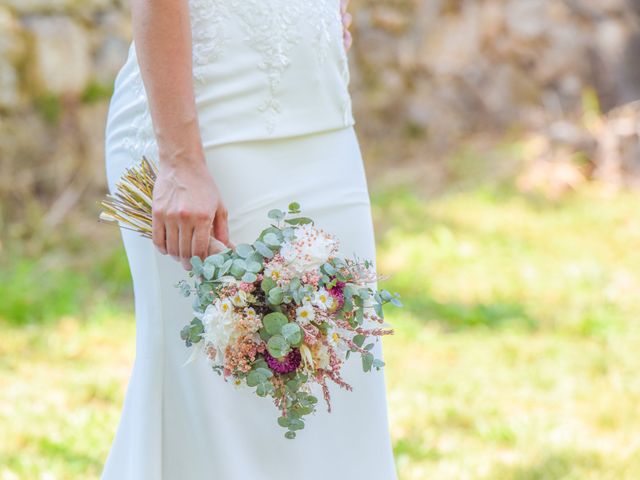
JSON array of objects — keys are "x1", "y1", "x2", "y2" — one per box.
[{"x1": 152, "y1": 159, "x2": 232, "y2": 270}]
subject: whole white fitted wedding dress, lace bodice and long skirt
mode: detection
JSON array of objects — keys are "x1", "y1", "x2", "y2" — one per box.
[{"x1": 102, "y1": 0, "x2": 396, "y2": 480}]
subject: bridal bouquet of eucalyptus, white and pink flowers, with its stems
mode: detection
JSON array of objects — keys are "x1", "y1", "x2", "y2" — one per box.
[{"x1": 102, "y1": 161, "x2": 401, "y2": 439}]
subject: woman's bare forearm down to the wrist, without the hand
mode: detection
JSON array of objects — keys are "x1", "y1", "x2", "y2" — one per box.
[{"x1": 131, "y1": 0, "x2": 203, "y2": 166}]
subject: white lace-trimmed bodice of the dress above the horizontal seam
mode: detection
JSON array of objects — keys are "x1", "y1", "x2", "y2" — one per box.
[{"x1": 112, "y1": 0, "x2": 353, "y2": 163}]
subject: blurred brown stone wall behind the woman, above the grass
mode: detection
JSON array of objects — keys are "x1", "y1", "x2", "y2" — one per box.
[{"x1": 0, "y1": 0, "x2": 640, "y2": 231}]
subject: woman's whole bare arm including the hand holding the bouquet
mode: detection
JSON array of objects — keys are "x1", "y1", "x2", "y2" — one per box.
[{"x1": 131, "y1": 0, "x2": 229, "y2": 268}]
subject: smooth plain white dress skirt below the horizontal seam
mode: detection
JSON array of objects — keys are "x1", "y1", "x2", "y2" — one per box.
[{"x1": 102, "y1": 122, "x2": 396, "y2": 480}]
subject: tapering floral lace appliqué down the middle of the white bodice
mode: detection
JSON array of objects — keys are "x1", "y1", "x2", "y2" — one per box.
[{"x1": 231, "y1": 0, "x2": 304, "y2": 133}]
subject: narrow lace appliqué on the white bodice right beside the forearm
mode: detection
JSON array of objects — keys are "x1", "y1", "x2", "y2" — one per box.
[{"x1": 189, "y1": 0, "x2": 228, "y2": 83}]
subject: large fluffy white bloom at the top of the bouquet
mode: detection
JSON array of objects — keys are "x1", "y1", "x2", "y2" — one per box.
[{"x1": 280, "y1": 224, "x2": 338, "y2": 274}]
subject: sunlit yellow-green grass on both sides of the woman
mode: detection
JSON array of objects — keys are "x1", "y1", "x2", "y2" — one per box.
[{"x1": 0, "y1": 183, "x2": 640, "y2": 480}]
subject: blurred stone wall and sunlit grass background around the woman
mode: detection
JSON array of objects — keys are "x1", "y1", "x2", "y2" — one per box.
[{"x1": 0, "y1": 0, "x2": 640, "y2": 480}]
